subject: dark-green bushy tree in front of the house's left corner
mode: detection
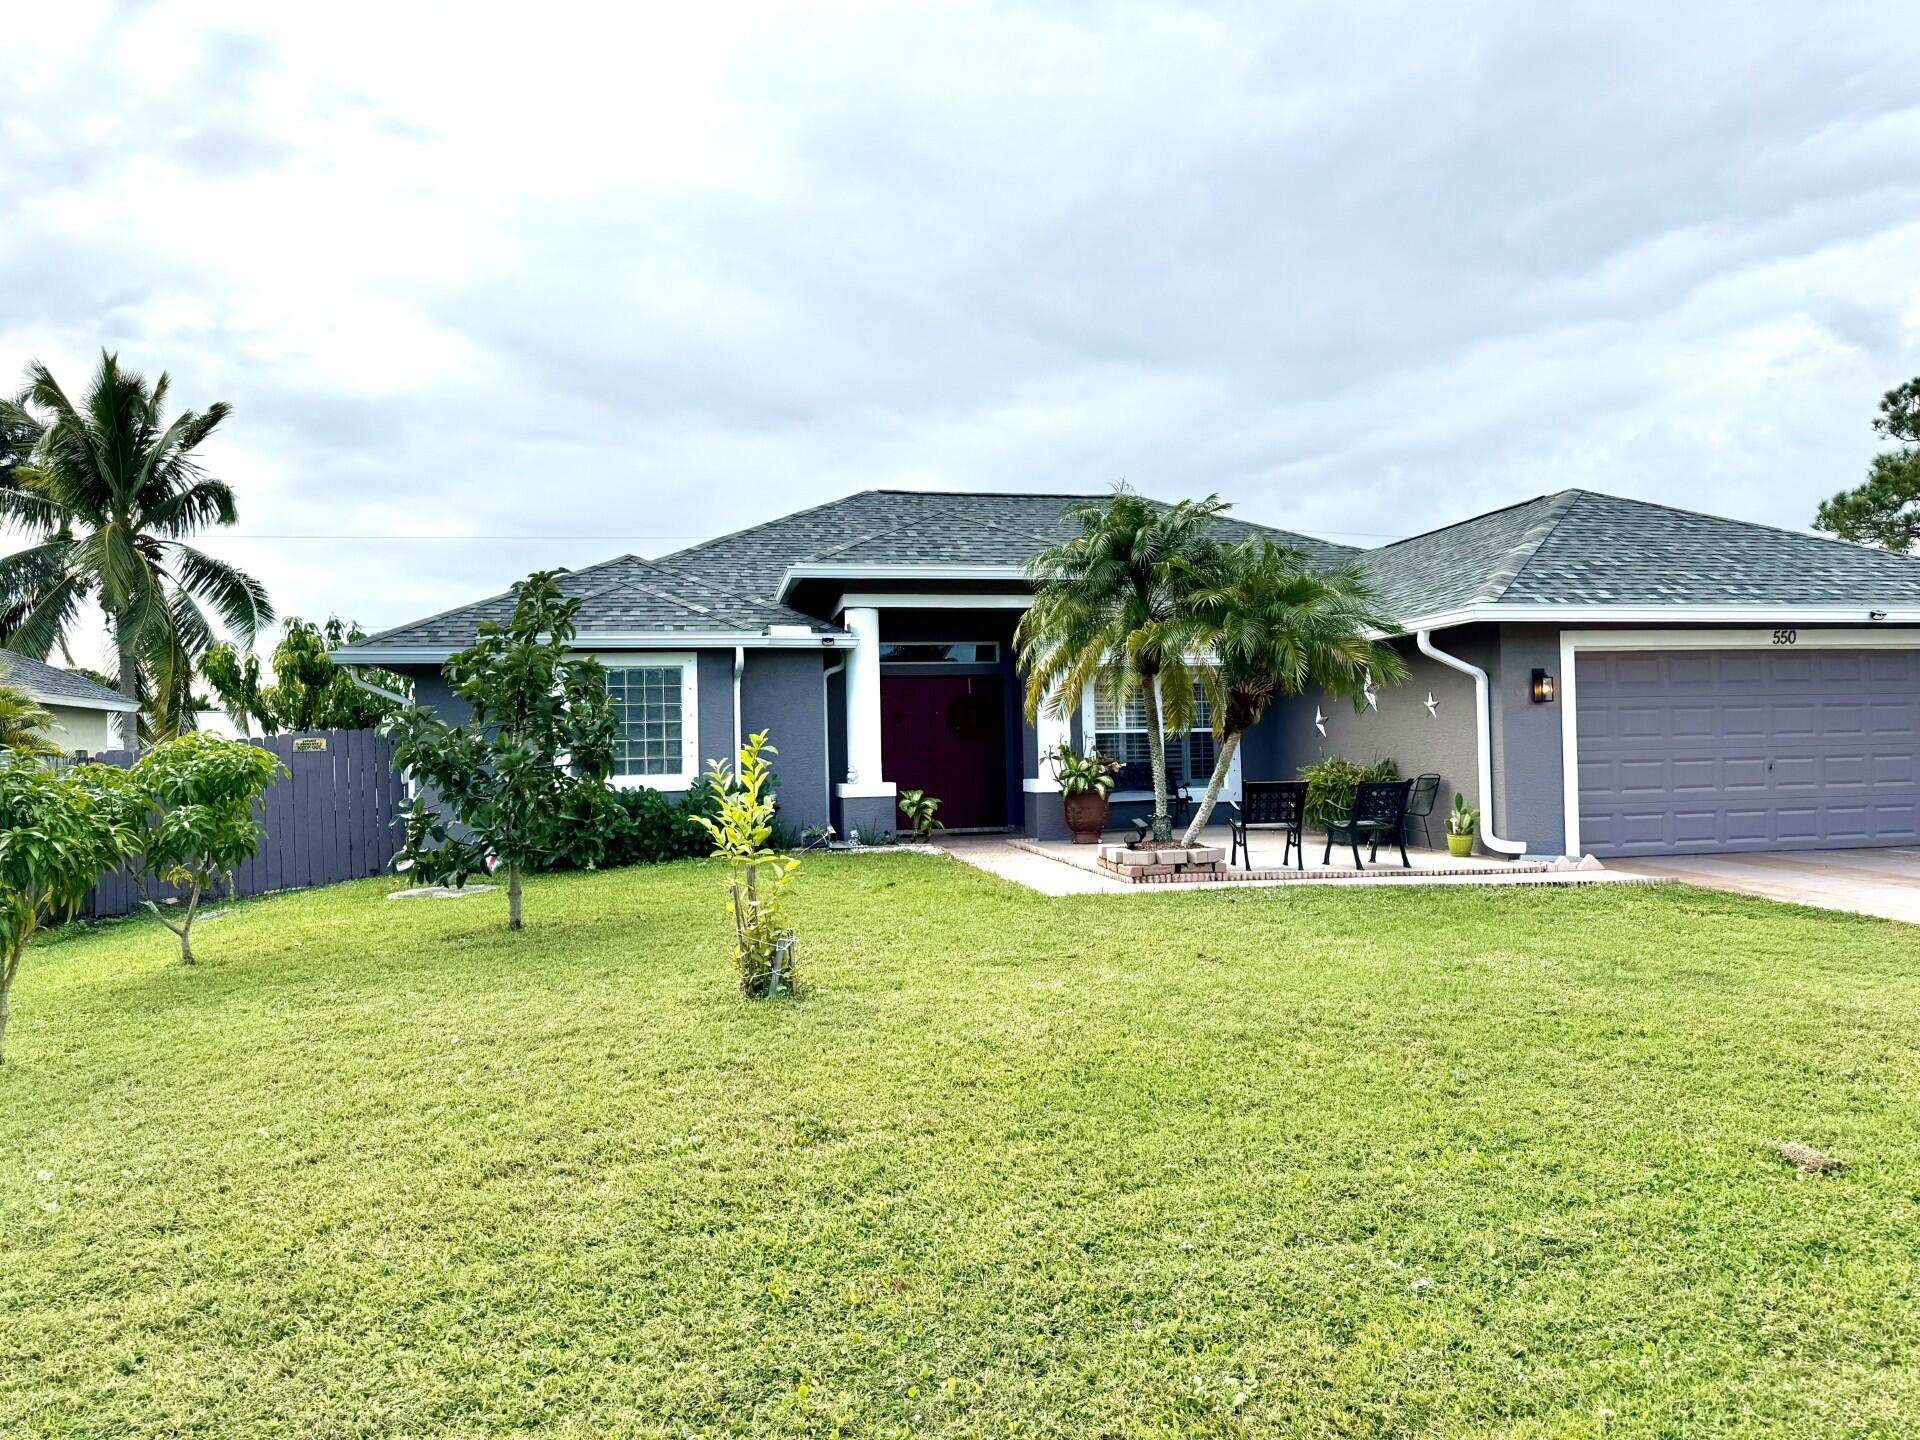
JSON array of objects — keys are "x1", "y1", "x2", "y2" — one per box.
[{"x1": 386, "y1": 570, "x2": 618, "y2": 929}]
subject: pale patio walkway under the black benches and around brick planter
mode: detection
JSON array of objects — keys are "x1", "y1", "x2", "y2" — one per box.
[{"x1": 939, "y1": 826, "x2": 1661, "y2": 895}]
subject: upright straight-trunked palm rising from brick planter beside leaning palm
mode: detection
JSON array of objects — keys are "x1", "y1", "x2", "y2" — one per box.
[{"x1": 1014, "y1": 484, "x2": 1227, "y2": 841}]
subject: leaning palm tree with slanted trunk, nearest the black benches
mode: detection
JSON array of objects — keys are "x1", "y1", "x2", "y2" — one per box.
[{"x1": 1160, "y1": 536, "x2": 1407, "y2": 845}]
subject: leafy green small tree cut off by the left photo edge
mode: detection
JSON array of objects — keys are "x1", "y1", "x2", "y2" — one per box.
[{"x1": 0, "y1": 755, "x2": 129, "y2": 1058}]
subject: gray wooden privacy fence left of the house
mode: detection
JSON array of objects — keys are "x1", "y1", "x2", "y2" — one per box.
[{"x1": 81, "y1": 730, "x2": 407, "y2": 918}]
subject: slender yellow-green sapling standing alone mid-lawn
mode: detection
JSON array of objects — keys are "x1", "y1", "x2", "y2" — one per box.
[{"x1": 693, "y1": 730, "x2": 801, "y2": 998}]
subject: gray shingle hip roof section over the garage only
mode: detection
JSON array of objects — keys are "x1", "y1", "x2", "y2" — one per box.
[{"x1": 1363, "y1": 490, "x2": 1920, "y2": 618}]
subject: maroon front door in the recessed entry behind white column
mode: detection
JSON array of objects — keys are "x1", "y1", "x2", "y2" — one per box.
[{"x1": 879, "y1": 674, "x2": 1006, "y2": 829}]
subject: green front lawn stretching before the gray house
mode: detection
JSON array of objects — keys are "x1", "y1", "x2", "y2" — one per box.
[{"x1": 0, "y1": 856, "x2": 1920, "y2": 1440}]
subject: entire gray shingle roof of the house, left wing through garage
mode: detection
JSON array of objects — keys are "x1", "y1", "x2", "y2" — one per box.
[{"x1": 345, "y1": 490, "x2": 1920, "y2": 664}]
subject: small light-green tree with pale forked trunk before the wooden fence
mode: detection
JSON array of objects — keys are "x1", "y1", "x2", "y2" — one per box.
[{"x1": 127, "y1": 733, "x2": 286, "y2": 966}]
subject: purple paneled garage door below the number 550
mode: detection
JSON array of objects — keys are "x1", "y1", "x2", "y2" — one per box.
[{"x1": 1574, "y1": 647, "x2": 1920, "y2": 854}]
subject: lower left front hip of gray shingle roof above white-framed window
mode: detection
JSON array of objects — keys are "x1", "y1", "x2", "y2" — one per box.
[{"x1": 338, "y1": 555, "x2": 847, "y2": 662}]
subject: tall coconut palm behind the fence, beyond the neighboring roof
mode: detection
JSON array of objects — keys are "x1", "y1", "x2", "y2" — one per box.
[{"x1": 0, "y1": 353, "x2": 273, "y2": 749}]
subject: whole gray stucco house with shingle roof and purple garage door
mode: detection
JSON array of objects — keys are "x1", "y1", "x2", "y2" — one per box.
[{"x1": 338, "y1": 490, "x2": 1920, "y2": 856}]
